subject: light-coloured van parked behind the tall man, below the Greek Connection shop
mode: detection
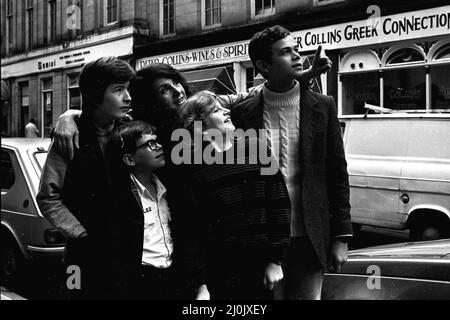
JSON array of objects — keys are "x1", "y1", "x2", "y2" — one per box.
[{"x1": 341, "y1": 113, "x2": 450, "y2": 241}]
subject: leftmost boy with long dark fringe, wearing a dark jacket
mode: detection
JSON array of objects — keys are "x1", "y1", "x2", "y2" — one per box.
[{"x1": 37, "y1": 57, "x2": 135, "y2": 299}]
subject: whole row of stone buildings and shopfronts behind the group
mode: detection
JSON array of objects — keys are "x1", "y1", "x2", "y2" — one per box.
[{"x1": 1, "y1": 0, "x2": 450, "y2": 136}]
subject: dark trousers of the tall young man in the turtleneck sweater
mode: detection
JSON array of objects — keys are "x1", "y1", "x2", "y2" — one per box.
[{"x1": 276, "y1": 237, "x2": 323, "y2": 300}]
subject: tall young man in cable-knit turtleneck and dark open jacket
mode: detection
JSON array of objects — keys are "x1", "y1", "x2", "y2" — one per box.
[{"x1": 231, "y1": 26, "x2": 353, "y2": 300}]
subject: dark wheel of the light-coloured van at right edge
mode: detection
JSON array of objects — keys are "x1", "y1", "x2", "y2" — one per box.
[{"x1": 409, "y1": 216, "x2": 450, "y2": 241}]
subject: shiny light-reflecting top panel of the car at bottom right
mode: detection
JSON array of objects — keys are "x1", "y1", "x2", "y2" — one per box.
[{"x1": 349, "y1": 239, "x2": 450, "y2": 258}]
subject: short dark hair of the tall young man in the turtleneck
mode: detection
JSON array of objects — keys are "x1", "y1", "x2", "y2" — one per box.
[{"x1": 248, "y1": 25, "x2": 291, "y2": 77}]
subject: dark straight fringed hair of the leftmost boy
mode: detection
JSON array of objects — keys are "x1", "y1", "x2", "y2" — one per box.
[{"x1": 79, "y1": 57, "x2": 136, "y2": 113}]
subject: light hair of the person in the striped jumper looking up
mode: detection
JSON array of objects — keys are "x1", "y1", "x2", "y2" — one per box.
[{"x1": 181, "y1": 90, "x2": 218, "y2": 134}]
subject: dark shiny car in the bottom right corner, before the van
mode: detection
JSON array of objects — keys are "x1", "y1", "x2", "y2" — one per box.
[{"x1": 322, "y1": 239, "x2": 450, "y2": 300}]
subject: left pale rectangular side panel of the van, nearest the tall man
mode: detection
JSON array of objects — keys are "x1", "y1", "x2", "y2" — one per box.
[{"x1": 345, "y1": 119, "x2": 409, "y2": 157}]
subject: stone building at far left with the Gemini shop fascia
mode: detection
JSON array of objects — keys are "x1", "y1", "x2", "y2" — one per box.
[{"x1": 0, "y1": 0, "x2": 150, "y2": 137}]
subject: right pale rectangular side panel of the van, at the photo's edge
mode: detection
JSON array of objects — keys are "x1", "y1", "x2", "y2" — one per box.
[{"x1": 408, "y1": 120, "x2": 450, "y2": 160}]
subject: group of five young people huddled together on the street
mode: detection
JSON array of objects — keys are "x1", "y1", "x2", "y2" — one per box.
[{"x1": 37, "y1": 26, "x2": 352, "y2": 300}]
